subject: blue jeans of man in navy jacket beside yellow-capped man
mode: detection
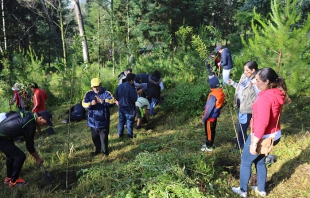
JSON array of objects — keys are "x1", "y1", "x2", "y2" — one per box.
[{"x1": 117, "y1": 107, "x2": 136, "y2": 138}]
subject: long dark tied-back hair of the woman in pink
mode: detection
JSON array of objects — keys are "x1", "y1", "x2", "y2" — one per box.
[{"x1": 257, "y1": 67, "x2": 291, "y2": 102}]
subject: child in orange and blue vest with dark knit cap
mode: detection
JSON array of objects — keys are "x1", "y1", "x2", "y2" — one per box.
[{"x1": 201, "y1": 75, "x2": 225, "y2": 151}]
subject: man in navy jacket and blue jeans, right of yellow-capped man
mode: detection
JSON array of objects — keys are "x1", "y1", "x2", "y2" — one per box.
[{"x1": 115, "y1": 73, "x2": 138, "y2": 138}]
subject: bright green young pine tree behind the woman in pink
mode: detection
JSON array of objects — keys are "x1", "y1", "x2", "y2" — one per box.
[{"x1": 243, "y1": 0, "x2": 310, "y2": 94}]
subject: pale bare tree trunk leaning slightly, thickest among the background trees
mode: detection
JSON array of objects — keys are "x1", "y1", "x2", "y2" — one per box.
[{"x1": 72, "y1": 0, "x2": 90, "y2": 67}]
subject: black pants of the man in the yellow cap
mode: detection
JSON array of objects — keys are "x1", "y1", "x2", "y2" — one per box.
[{"x1": 90, "y1": 127, "x2": 109, "y2": 155}]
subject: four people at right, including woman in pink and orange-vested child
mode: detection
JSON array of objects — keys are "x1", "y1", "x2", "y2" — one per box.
[{"x1": 201, "y1": 46, "x2": 290, "y2": 197}]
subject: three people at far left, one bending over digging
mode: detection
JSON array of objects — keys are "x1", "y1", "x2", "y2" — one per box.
[{"x1": 0, "y1": 82, "x2": 53, "y2": 187}]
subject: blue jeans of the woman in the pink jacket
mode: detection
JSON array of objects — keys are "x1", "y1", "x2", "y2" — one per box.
[{"x1": 240, "y1": 135, "x2": 267, "y2": 192}]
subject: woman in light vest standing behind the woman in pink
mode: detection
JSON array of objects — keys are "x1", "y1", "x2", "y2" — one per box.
[{"x1": 227, "y1": 61, "x2": 259, "y2": 151}]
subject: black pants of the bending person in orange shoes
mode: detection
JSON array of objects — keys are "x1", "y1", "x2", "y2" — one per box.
[{"x1": 0, "y1": 139, "x2": 26, "y2": 182}]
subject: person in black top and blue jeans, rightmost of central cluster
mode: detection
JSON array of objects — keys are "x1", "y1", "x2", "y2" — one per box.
[{"x1": 146, "y1": 70, "x2": 164, "y2": 116}]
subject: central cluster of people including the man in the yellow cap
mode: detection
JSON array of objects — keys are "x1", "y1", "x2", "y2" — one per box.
[{"x1": 81, "y1": 68, "x2": 164, "y2": 156}]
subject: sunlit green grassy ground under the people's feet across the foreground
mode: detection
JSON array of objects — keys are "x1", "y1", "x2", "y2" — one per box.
[{"x1": 0, "y1": 98, "x2": 310, "y2": 198}]
